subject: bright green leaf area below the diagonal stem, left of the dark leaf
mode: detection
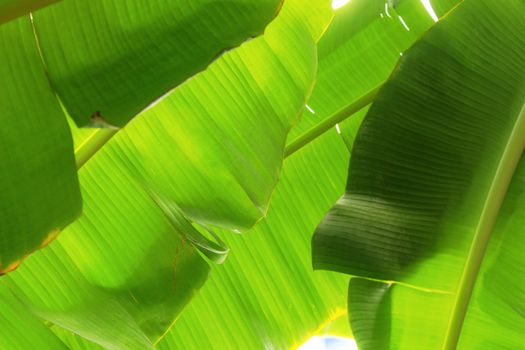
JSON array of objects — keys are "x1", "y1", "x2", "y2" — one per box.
[{"x1": 159, "y1": 130, "x2": 351, "y2": 350}]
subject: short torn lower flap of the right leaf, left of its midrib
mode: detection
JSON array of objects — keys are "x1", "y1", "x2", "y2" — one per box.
[{"x1": 348, "y1": 277, "x2": 452, "y2": 350}]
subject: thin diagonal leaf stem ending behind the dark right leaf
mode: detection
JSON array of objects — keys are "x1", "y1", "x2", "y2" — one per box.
[{"x1": 284, "y1": 83, "x2": 383, "y2": 158}]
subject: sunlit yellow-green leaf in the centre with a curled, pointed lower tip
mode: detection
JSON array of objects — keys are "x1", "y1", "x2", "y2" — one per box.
[{"x1": 101, "y1": 0, "x2": 332, "y2": 231}]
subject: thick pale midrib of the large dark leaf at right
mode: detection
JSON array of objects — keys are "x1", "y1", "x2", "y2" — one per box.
[{"x1": 442, "y1": 103, "x2": 525, "y2": 350}]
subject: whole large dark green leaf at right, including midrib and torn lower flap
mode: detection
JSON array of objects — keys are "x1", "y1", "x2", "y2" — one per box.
[{"x1": 313, "y1": 0, "x2": 525, "y2": 350}]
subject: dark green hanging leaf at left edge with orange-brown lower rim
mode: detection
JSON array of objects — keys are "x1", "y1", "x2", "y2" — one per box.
[{"x1": 0, "y1": 17, "x2": 81, "y2": 275}]
